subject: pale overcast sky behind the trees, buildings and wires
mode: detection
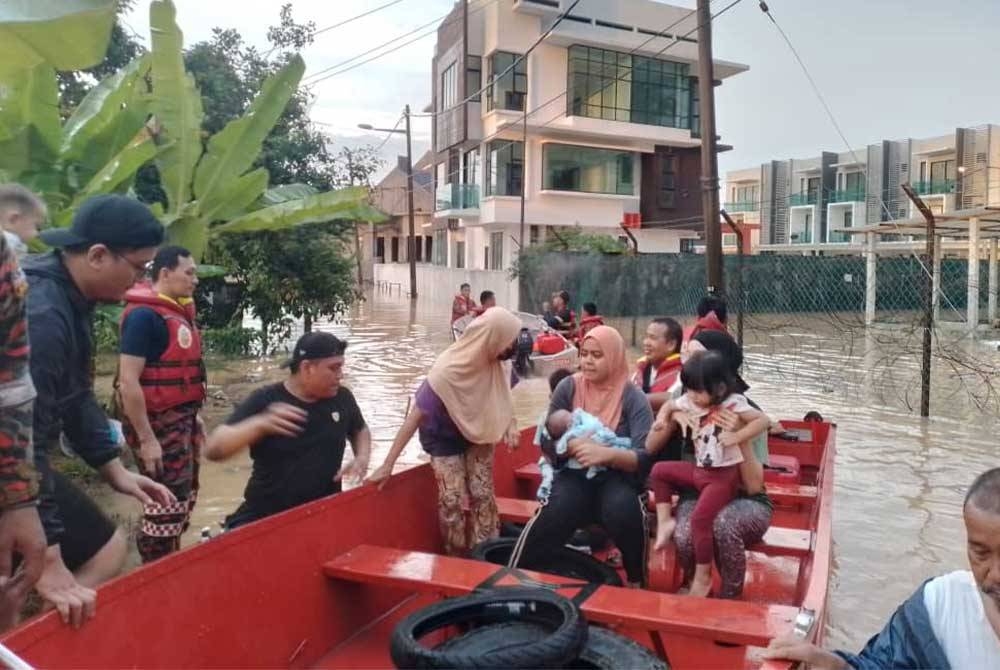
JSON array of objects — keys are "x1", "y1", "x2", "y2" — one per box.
[{"x1": 126, "y1": 0, "x2": 1000, "y2": 180}]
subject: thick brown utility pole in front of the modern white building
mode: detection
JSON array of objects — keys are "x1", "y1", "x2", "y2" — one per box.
[{"x1": 697, "y1": 0, "x2": 725, "y2": 296}]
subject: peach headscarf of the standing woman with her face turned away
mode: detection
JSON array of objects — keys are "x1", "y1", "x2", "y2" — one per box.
[{"x1": 427, "y1": 307, "x2": 521, "y2": 444}]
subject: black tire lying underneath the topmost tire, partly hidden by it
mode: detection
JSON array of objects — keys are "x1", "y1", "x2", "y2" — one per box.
[{"x1": 438, "y1": 623, "x2": 670, "y2": 670}]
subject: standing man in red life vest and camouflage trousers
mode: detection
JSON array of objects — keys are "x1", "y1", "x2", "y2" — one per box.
[{"x1": 118, "y1": 246, "x2": 205, "y2": 562}]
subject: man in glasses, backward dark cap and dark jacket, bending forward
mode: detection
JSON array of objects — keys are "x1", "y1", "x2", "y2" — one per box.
[{"x1": 24, "y1": 195, "x2": 173, "y2": 626}]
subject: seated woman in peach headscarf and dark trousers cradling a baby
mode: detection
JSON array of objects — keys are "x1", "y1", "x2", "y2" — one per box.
[{"x1": 511, "y1": 326, "x2": 653, "y2": 586}]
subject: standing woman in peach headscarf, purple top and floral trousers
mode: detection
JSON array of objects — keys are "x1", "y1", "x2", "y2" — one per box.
[{"x1": 368, "y1": 307, "x2": 521, "y2": 554}]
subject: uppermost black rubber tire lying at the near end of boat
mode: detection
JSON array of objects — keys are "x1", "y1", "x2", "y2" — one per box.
[{"x1": 389, "y1": 587, "x2": 587, "y2": 668}]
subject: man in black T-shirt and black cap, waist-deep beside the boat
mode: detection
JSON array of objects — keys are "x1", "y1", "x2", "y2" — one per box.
[{"x1": 205, "y1": 332, "x2": 371, "y2": 530}]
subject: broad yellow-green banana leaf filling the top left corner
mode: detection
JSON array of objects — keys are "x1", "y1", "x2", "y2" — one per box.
[{"x1": 0, "y1": 0, "x2": 117, "y2": 70}]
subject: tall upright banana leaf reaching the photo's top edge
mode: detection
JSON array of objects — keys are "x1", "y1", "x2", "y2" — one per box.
[{"x1": 149, "y1": 0, "x2": 204, "y2": 211}]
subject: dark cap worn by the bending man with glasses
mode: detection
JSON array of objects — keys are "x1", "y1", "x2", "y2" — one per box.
[{"x1": 38, "y1": 195, "x2": 164, "y2": 249}]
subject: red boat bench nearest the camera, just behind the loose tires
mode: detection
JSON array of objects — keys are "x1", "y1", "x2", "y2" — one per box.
[{"x1": 323, "y1": 544, "x2": 798, "y2": 647}]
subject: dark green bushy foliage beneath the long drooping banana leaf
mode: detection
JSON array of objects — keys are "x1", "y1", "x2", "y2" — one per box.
[{"x1": 214, "y1": 222, "x2": 354, "y2": 351}]
